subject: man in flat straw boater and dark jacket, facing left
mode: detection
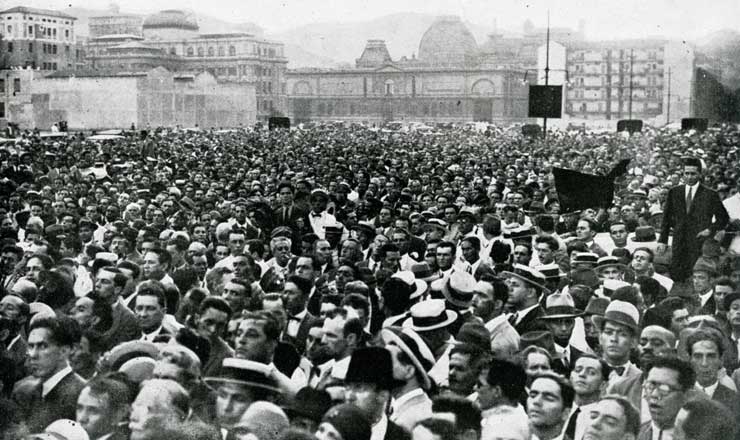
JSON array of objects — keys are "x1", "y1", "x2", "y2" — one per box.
[{"x1": 502, "y1": 264, "x2": 547, "y2": 335}]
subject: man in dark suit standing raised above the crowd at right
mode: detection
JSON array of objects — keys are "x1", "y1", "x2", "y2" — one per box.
[{"x1": 657, "y1": 157, "x2": 729, "y2": 282}]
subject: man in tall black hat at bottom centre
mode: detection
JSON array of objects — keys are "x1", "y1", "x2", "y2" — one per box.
[{"x1": 345, "y1": 347, "x2": 411, "y2": 440}]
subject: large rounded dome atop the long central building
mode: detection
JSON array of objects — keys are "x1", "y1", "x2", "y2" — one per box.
[{"x1": 419, "y1": 15, "x2": 478, "y2": 64}]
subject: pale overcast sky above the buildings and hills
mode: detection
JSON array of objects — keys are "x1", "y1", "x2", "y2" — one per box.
[{"x1": 7, "y1": 0, "x2": 740, "y2": 39}]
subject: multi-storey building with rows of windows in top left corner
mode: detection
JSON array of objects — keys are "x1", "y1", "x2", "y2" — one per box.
[{"x1": 0, "y1": 6, "x2": 84, "y2": 70}]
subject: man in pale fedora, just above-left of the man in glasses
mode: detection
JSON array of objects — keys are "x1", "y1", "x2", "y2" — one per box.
[{"x1": 593, "y1": 300, "x2": 642, "y2": 385}]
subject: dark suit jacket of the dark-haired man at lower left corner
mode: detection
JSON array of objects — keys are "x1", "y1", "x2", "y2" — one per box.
[{"x1": 12, "y1": 372, "x2": 85, "y2": 432}]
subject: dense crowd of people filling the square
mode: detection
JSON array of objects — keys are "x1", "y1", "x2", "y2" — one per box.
[{"x1": 0, "y1": 124, "x2": 740, "y2": 440}]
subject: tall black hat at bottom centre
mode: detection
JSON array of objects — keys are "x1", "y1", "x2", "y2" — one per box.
[{"x1": 344, "y1": 347, "x2": 400, "y2": 390}]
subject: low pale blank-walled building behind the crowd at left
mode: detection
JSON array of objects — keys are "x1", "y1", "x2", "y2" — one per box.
[{"x1": 0, "y1": 67, "x2": 257, "y2": 130}]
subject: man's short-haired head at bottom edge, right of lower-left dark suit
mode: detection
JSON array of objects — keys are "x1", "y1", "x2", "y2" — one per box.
[{"x1": 76, "y1": 375, "x2": 132, "y2": 438}]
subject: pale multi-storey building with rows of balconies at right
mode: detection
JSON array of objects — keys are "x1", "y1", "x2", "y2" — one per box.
[{"x1": 564, "y1": 39, "x2": 696, "y2": 125}]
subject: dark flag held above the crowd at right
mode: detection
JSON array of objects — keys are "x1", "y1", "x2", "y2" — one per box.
[{"x1": 552, "y1": 159, "x2": 630, "y2": 213}]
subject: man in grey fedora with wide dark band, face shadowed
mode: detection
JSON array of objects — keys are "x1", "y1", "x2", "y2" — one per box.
[{"x1": 540, "y1": 292, "x2": 583, "y2": 376}]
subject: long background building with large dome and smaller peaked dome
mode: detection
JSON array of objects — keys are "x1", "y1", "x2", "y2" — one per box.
[{"x1": 287, "y1": 16, "x2": 527, "y2": 123}]
